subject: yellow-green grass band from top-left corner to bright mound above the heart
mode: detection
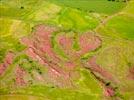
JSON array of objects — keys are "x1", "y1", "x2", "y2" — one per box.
[{"x1": 0, "y1": 0, "x2": 99, "y2": 31}]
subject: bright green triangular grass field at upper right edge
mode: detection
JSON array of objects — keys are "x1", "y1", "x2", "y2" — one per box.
[{"x1": 97, "y1": 1, "x2": 134, "y2": 40}]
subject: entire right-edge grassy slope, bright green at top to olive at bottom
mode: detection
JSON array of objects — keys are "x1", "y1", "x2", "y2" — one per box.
[{"x1": 97, "y1": 1, "x2": 134, "y2": 100}]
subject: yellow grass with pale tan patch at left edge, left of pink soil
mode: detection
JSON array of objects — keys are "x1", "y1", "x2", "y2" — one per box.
[{"x1": 0, "y1": 18, "x2": 32, "y2": 62}]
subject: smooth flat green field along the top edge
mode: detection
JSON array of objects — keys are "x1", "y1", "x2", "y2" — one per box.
[{"x1": 48, "y1": 0, "x2": 125, "y2": 14}]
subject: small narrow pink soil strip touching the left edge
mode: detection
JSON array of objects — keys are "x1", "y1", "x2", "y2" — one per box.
[{"x1": 0, "y1": 52, "x2": 14, "y2": 75}]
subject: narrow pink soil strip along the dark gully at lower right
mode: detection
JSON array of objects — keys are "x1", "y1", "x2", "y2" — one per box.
[{"x1": 85, "y1": 57, "x2": 117, "y2": 96}]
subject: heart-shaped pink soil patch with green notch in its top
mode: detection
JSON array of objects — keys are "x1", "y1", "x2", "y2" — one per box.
[{"x1": 57, "y1": 33, "x2": 101, "y2": 59}]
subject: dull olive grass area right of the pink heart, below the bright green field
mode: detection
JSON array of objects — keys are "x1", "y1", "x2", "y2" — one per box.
[{"x1": 96, "y1": 38, "x2": 134, "y2": 100}]
